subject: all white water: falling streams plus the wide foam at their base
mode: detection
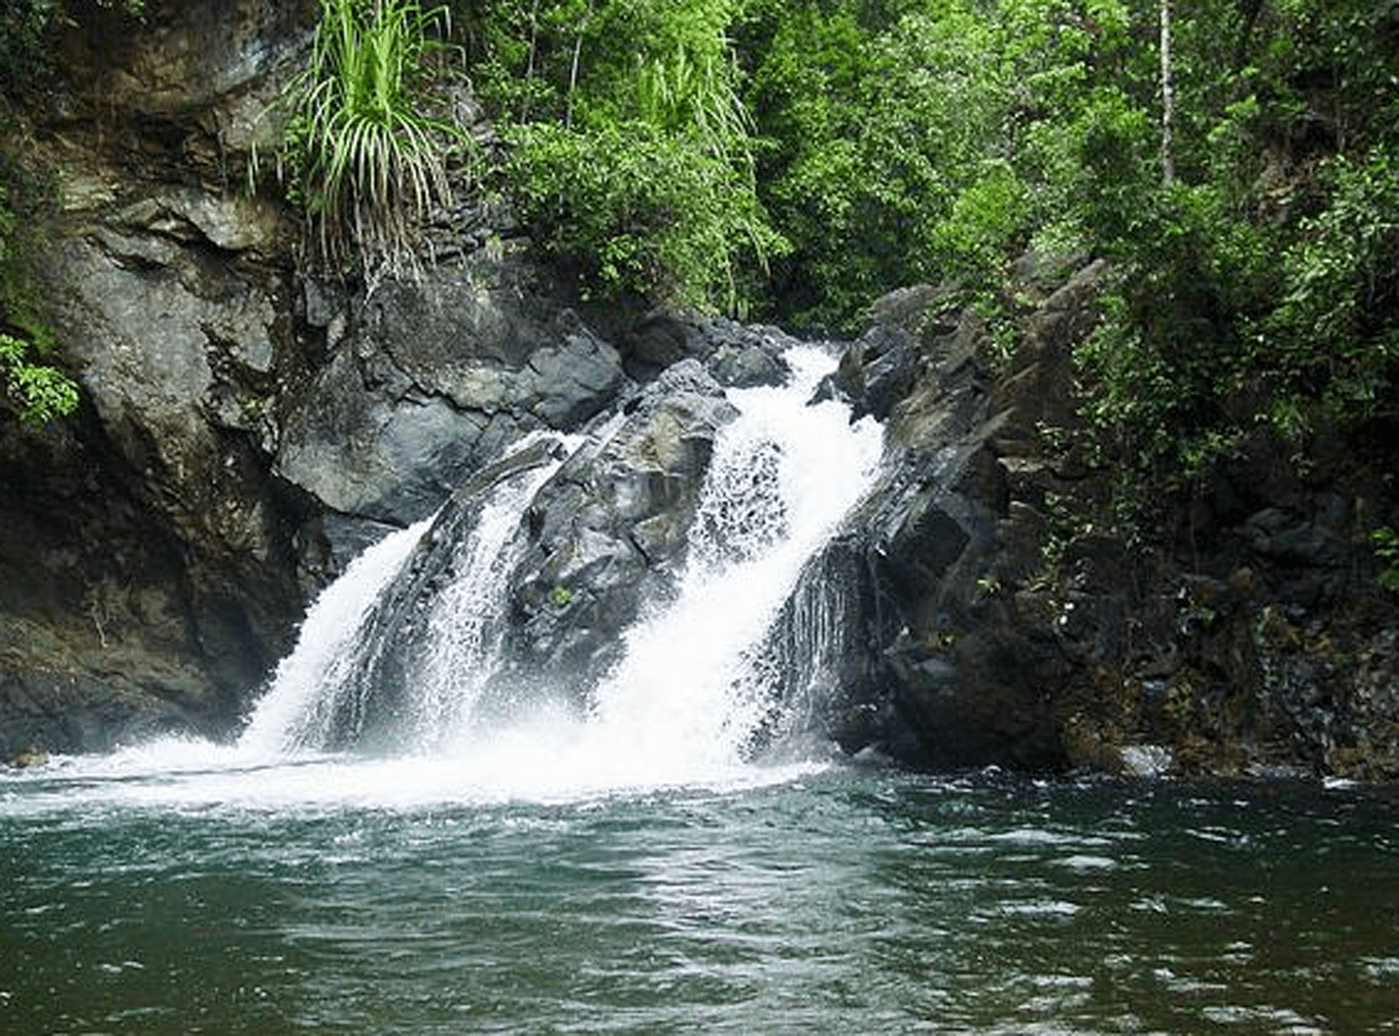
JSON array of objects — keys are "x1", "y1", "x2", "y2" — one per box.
[{"x1": 16, "y1": 348, "x2": 880, "y2": 810}]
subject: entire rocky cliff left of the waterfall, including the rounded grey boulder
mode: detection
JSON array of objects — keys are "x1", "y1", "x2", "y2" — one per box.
[{"x1": 0, "y1": 0, "x2": 618, "y2": 755}]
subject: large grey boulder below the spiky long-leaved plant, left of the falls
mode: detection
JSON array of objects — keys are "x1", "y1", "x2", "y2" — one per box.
[{"x1": 276, "y1": 260, "x2": 625, "y2": 542}]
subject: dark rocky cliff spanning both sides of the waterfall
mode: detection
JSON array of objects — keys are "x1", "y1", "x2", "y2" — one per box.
[{"x1": 0, "y1": 0, "x2": 1399, "y2": 779}]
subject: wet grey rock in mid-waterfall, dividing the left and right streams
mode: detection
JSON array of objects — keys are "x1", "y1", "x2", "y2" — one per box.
[{"x1": 290, "y1": 343, "x2": 789, "y2": 749}]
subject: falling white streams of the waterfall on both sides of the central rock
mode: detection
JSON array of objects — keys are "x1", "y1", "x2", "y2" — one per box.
[{"x1": 235, "y1": 347, "x2": 881, "y2": 787}]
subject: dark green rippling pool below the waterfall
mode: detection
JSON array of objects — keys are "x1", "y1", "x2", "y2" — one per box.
[{"x1": 0, "y1": 761, "x2": 1399, "y2": 1036}]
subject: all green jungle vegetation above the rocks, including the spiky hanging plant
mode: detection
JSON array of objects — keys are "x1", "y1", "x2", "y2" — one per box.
[{"x1": 0, "y1": 0, "x2": 1399, "y2": 500}]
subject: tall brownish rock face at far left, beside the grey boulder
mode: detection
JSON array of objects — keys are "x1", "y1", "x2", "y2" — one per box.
[{"x1": 0, "y1": 1, "x2": 309, "y2": 754}]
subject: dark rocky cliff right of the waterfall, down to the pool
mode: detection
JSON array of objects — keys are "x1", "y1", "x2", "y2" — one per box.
[{"x1": 774, "y1": 264, "x2": 1399, "y2": 779}]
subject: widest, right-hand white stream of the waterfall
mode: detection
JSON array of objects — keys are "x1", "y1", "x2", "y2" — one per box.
[{"x1": 570, "y1": 347, "x2": 881, "y2": 775}]
